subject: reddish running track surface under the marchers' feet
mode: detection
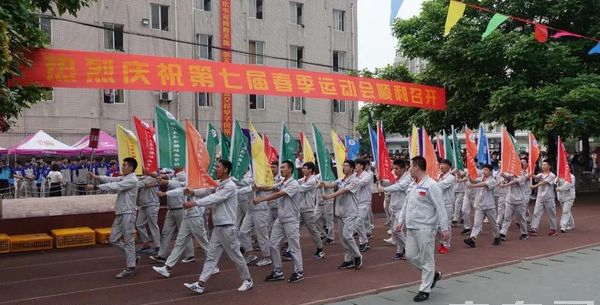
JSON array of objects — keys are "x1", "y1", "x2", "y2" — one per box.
[{"x1": 0, "y1": 194, "x2": 600, "y2": 305}]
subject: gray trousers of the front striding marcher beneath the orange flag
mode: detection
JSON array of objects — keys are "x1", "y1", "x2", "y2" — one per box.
[{"x1": 198, "y1": 225, "x2": 251, "y2": 283}]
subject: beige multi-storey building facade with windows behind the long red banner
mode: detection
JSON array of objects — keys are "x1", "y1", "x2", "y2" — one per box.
[{"x1": 0, "y1": 0, "x2": 358, "y2": 147}]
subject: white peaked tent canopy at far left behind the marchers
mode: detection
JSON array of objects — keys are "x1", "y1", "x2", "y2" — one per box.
[{"x1": 8, "y1": 130, "x2": 80, "y2": 155}]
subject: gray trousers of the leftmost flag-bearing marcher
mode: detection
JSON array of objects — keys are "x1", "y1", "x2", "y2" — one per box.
[{"x1": 109, "y1": 214, "x2": 136, "y2": 268}]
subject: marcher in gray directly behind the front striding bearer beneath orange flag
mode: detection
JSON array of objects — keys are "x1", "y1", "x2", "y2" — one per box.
[{"x1": 254, "y1": 160, "x2": 304, "y2": 283}]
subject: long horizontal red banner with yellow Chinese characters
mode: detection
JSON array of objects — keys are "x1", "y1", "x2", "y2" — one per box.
[{"x1": 13, "y1": 49, "x2": 446, "y2": 110}]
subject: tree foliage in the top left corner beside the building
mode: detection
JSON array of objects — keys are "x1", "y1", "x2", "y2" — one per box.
[{"x1": 0, "y1": 0, "x2": 94, "y2": 132}]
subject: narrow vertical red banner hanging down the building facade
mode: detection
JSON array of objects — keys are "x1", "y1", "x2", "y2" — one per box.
[{"x1": 221, "y1": 0, "x2": 233, "y2": 136}]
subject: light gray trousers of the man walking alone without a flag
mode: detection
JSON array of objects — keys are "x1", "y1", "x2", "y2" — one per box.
[{"x1": 406, "y1": 228, "x2": 437, "y2": 293}]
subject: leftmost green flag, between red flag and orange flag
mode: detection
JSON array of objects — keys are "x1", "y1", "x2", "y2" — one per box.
[{"x1": 154, "y1": 106, "x2": 186, "y2": 168}]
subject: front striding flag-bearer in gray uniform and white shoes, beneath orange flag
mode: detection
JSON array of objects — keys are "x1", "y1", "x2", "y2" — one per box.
[{"x1": 183, "y1": 160, "x2": 254, "y2": 294}]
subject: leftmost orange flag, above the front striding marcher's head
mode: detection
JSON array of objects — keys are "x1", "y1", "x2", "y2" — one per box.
[{"x1": 185, "y1": 120, "x2": 219, "y2": 189}]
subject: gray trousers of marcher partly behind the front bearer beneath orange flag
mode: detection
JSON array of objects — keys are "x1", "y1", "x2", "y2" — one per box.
[{"x1": 165, "y1": 216, "x2": 209, "y2": 268}]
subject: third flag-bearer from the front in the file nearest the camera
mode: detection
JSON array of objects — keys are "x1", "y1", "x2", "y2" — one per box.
[{"x1": 321, "y1": 160, "x2": 363, "y2": 270}]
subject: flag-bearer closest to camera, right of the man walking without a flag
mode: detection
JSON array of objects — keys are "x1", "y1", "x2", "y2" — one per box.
[{"x1": 464, "y1": 164, "x2": 500, "y2": 248}]
